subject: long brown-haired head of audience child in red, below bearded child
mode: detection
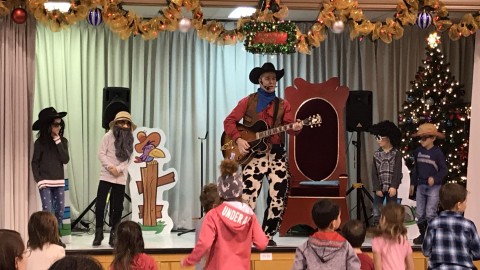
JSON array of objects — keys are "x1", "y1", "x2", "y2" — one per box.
[{"x1": 112, "y1": 221, "x2": 145, "y2": 270}]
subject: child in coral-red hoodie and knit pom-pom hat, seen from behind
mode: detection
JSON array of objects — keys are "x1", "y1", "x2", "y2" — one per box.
[{"x1": 181, "y1": 160, "x2": 268, "y2": 270}]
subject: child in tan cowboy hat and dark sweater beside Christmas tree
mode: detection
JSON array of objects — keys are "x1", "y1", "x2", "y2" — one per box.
[{"x1": 410, "y1": 123, "x2": 448, "y2": 245}]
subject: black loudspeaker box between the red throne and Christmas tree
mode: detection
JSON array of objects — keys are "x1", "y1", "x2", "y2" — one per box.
[{"x1": 346, "y1": 91, "x2": 373, "y2": 132}]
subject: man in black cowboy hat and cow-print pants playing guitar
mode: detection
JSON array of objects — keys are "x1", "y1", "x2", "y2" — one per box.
[{"x1": 223, "y1": 63, "x2": 302, "y2": 246}]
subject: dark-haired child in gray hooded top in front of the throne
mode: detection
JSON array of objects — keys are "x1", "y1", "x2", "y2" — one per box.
[{"x1": 292, "y1": 199, "x2": 360, "y2": 270}]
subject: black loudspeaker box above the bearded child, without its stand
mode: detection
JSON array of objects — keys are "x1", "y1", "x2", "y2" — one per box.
[{"x1": 102, "y1": 86, "x2": 130, "y2": 129}]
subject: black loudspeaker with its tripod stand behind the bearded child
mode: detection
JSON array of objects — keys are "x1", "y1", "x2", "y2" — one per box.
[{"x1": 71, "y1": 86, "x2": 132, "y2": 229}]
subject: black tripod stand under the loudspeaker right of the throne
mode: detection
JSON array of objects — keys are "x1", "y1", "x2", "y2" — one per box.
[{"x1": 347, "y1": 131, "x2": 373, "y2": 228}]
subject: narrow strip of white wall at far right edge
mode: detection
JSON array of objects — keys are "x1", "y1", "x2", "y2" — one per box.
[{"x1": 465, "y1": 31, "x2": 480, "y2": 229}]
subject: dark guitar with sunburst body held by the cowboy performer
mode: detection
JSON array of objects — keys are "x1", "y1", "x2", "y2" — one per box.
[{"x1": 221, "y1": 114, "x2": 322, "y2": 165}]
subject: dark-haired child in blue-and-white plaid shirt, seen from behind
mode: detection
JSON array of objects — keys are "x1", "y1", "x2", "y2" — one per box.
[{"x1": 422, "y1": 183, "x2": 480, "y2": 270}]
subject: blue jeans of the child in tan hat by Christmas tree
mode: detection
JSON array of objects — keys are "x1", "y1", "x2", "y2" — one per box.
[{"x1": 416, "y1": 185, "x2": 441, "y2": 223}]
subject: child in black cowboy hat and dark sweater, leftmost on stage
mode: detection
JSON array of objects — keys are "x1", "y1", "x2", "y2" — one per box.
[{"x1": 31, "y1": 107, "x2": 70, "y2": 246}]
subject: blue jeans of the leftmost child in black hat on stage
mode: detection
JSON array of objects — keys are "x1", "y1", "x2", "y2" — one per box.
[{"x1": 40, "y1": 187, "x2": 65, "y2": 230}]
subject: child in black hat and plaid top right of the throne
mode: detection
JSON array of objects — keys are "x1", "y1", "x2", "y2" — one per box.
[{"x1": 370, "y1": 120, "x2": 403, "y2": 225}]
